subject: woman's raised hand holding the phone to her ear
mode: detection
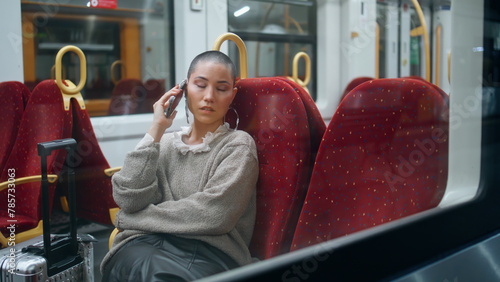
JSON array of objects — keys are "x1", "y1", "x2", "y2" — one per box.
[{"x1": 148, "y1": 85, "x2": 182, "y2": 142}]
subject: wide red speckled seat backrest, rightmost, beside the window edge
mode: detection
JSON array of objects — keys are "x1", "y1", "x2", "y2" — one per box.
[{"x1": 292, "y1": 79, "x2": 448, "y2": 250}]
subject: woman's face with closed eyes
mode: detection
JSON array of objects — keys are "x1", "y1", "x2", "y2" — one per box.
[{"x1": 186, "y1": 61, "x2": 237, "y2": 131}]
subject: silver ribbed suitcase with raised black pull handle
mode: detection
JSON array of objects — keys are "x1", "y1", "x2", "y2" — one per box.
[{"x1": 0, "y1": 138, "x2": 95, "y2": 282}]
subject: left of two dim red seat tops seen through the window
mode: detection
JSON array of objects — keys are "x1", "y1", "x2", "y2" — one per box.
[{"x1": 108, "y1": 79, "x2": 147, "y2": 115}]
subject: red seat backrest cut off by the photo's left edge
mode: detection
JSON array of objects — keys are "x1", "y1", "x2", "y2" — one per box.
[{"x1": 0, "y1": 81, "x2": 31, "y2": 171}]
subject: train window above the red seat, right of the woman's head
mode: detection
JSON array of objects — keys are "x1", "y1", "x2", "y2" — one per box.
[{"x1": 228, "y1": 0, "x2": 316, "y2": 97}]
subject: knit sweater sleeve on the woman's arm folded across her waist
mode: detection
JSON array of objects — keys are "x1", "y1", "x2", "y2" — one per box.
[{"x1": 117, "y1": 140, "x2": 259, "y2": 235}]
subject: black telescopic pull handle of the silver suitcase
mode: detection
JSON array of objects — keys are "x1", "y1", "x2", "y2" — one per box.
[{"x1": 38, "y1": 138, "x2": 78, "y2": 272}]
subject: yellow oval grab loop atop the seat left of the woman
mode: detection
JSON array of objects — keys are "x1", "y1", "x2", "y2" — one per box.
[{"x1": 56, "y1": 45, "x2": 87, "y2": 94}]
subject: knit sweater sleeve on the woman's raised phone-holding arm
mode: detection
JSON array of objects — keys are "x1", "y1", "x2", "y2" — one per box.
[{"x1": 112, "y1": 143, "x2": 162, "y2": 213}]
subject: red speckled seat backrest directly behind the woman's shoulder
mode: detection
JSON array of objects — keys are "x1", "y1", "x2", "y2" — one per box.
[{"x1": 228, "y1": 78, "x2": 310, "y2": 259}]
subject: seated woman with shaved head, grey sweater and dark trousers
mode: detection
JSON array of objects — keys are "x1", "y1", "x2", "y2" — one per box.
[{"x1": 101, "y1": 51, "x2": 258, "y2": 281}]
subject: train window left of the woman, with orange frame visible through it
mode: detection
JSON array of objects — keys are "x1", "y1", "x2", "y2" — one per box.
[{"x1": 21, "y1": 0, "x2": 174, "y2": 116}]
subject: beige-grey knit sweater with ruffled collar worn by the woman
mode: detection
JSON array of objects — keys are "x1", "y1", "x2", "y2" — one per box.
[{"x1": 101, "y1": 126, "x2": 259, "y2": 271}]
